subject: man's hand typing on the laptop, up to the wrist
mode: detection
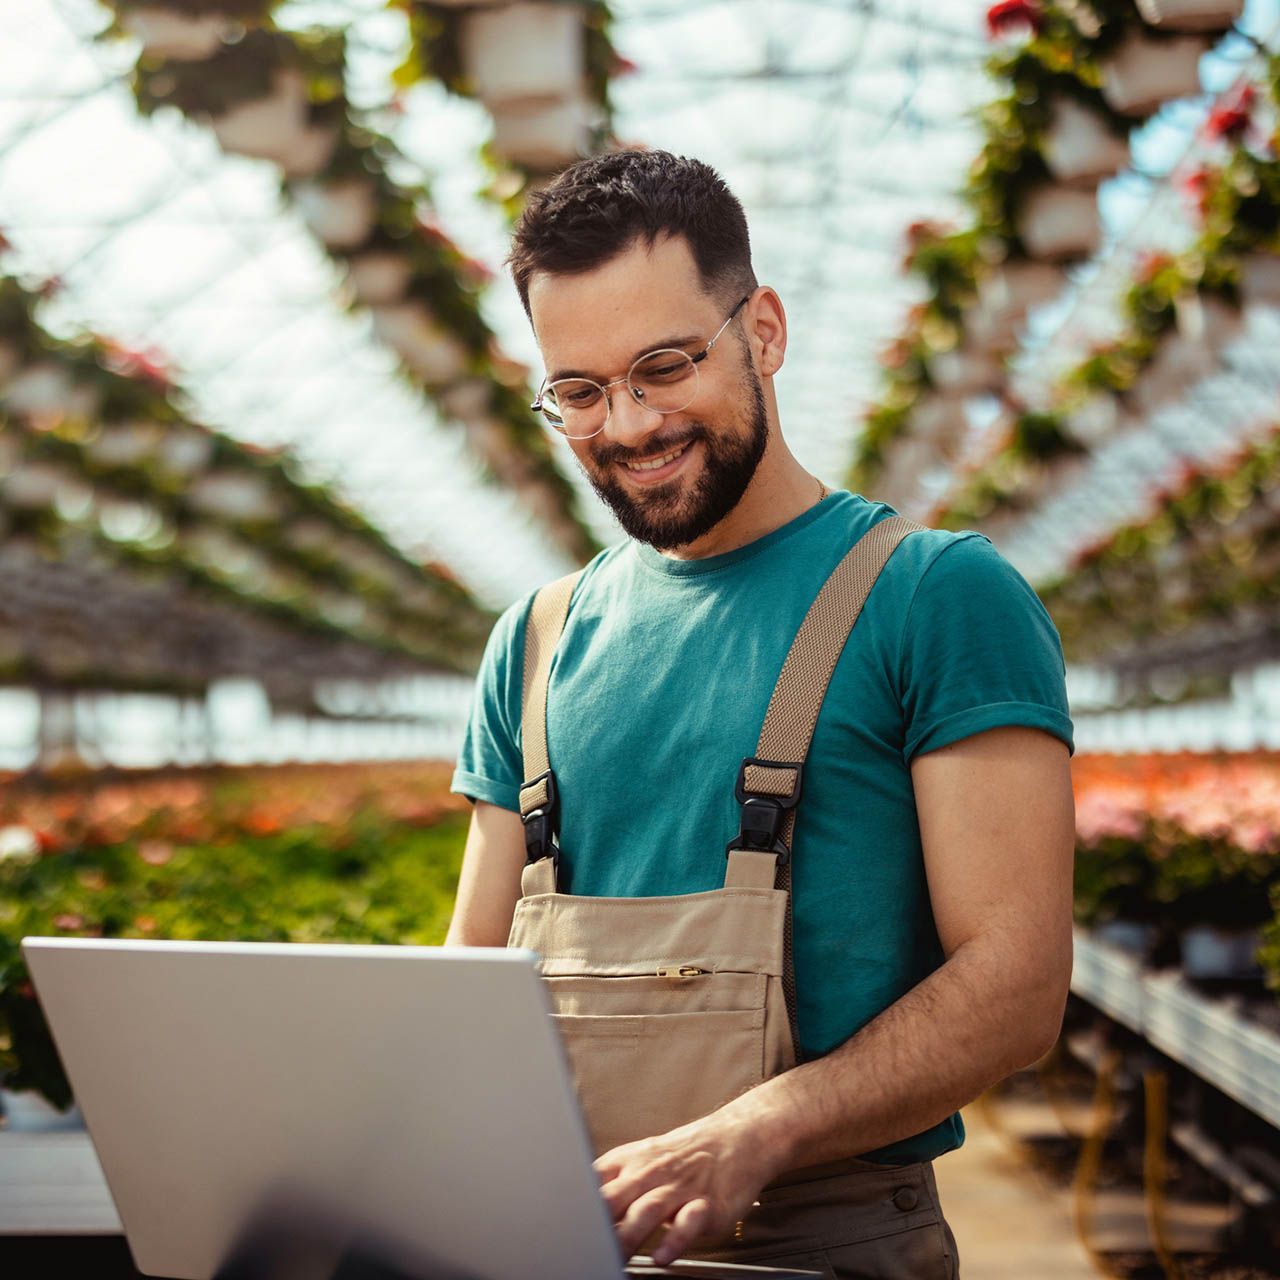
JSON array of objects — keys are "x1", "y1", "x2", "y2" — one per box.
[{"x1": 594, "y1": 1108, "x2": 782, "y2": 1266}]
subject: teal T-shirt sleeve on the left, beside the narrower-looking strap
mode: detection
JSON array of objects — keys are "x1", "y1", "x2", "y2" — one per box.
[{"x1": 449, "y1": 593, "x2": 534, "y2": 813}]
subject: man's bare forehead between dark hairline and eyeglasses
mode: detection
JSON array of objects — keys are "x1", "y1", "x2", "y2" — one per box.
[{"x1": 529, "y1": 237, "x2": 716, "y2": 375}]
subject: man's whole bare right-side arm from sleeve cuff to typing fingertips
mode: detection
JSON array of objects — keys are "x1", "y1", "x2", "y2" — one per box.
[{"x1": 596, "y1": 726, "x2": 1075, "y2": 1262}]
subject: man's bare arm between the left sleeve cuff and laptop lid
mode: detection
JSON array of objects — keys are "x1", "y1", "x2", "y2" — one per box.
[{"x1": 444, "y1": 800, "x2": 525, "y2": 947}]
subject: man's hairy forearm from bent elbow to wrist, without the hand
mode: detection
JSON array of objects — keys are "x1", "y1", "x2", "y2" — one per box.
[{"x1": 722, "y1": 938, "x2": 1065, "y2": 1171}]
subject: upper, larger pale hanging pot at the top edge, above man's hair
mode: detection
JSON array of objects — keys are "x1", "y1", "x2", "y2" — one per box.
[{"x1": 458, "y1": 4, "x2": 586, "y2": 108}]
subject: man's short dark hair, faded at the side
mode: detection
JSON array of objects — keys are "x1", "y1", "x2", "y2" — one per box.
[{"x1": 507, "y1": 151, "x2": 755, "y2": 315}]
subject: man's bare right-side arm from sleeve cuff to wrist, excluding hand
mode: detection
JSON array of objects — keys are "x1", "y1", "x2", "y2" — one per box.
[{"x1": 742, "y1": 726, "x2": 1075, "y2": 1166}]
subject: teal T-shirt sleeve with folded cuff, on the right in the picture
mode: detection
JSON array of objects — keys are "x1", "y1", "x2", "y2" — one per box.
[{"x1": 899, "y1": 531, "x2": 1075, "y2": 762}]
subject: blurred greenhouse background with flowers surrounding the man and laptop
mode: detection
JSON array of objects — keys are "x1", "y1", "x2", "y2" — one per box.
[{"x1": 0, "y1": 0, "x2": 1280, "y2": 1280}]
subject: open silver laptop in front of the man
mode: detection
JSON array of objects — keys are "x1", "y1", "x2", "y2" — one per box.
[{"x1": 22, "y1": 937, "x2": 820, "y2": 1280}]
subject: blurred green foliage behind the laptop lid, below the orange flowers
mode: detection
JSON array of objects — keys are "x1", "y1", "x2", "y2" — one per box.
[{"x1": 0, "y1": 809, "x2": 467, "y2": 1107}]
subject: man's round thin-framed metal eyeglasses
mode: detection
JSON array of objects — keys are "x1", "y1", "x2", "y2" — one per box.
[{"x1": 529, "y1": 293, "x2": 751, "y2": 440}]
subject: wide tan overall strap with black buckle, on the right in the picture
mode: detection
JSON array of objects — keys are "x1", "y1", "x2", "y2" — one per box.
[{"x1": 724, "y1": 516, "x2": 928, "y2": 1061}]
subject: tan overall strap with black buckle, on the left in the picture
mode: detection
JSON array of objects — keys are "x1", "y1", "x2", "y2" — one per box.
[{"x1": 520, "y1": 570, "x2": 582, "y2": 896}]
